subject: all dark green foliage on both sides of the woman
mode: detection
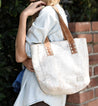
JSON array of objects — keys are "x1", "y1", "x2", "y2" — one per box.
[{"x1": 0, "y1": 0, "x2": 98, "y2": 106}]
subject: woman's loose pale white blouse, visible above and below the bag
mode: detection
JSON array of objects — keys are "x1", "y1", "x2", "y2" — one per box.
[{"x1": 14, "y1": 4, "x2": 68, "y2": 106}]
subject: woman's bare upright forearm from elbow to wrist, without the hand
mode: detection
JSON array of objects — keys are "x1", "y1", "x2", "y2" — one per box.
[{"x1": 15, "y1": 13, "x2": 27, "y2": 62}]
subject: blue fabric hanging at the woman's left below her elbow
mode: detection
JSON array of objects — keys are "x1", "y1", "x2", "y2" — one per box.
[{"x1": 12, "y1": 67, "x2": 26, "y2": 93}]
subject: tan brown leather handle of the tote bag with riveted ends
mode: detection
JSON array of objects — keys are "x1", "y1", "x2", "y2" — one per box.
[{"x1": 44, "y1": 6, "x2": 77, "y2": 56}]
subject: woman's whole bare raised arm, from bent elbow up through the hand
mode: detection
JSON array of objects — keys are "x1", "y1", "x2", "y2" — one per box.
[{"x1": 15, "y1": 1, "x2": 45, "y2": 62}]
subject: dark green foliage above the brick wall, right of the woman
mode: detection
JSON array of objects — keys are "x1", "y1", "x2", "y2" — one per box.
[{"x1": 65, "y1": 0, "x2": 98, "y2": 22}]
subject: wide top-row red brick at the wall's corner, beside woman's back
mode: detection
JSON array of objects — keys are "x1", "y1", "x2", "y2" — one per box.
[{"x1": 69, "y1": 22, "x2": 91, "y2": 32}]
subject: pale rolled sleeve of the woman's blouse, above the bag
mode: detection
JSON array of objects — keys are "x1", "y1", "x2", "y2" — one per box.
[{"x1": 26, "y1": 9, "x2": 57, "y2": 58}]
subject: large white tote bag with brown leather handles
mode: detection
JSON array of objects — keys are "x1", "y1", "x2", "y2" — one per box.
[{"x1": 31, "y1": 7, "x2": 90, "y2": 95}]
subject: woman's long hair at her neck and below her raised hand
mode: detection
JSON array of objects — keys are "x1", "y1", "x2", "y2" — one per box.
[{"x1": 27, "y1": 0, "x2": 60, "y2": 31}]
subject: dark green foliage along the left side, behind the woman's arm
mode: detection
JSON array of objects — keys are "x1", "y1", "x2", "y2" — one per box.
[{"x1": 0, "y1": 0, "x2": 27, "y2": 106}]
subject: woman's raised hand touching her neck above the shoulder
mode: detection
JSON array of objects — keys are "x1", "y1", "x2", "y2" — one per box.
[{"x1": 22, "y1": 0, "x2": 45, "y2": 17}]
